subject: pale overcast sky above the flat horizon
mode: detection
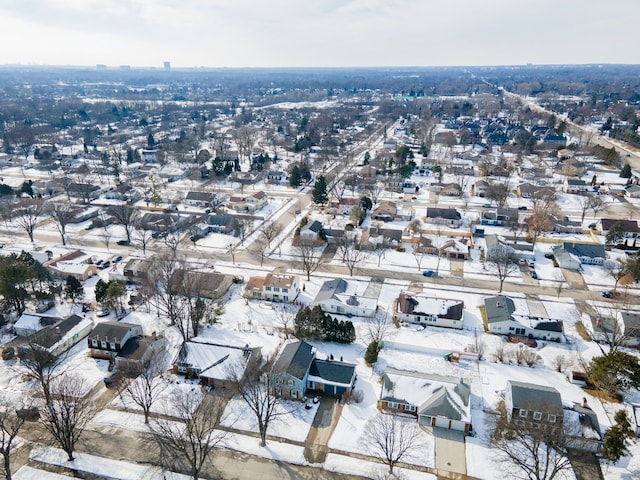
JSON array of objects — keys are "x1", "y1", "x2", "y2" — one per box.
[{"x1": 0, "y1": 0, "x2": 640, "y2": 67}]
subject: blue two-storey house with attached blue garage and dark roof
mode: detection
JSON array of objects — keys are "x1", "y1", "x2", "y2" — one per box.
[{"x1": 269, "y1": 341, "x2": 356, "y2": 400}]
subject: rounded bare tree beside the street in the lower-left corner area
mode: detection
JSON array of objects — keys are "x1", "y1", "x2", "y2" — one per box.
[{"x1": 42, "y1": 375, "x2": 95, "y2": 462}]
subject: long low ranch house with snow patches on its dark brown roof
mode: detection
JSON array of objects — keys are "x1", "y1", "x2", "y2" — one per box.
[{"x1": 396, "y1": 292, "x2": 464, "y2": 329}]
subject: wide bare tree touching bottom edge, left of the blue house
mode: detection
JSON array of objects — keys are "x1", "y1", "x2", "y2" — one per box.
[{"x1": 152, "y1": 391, "x2": 225, "y2": 480}]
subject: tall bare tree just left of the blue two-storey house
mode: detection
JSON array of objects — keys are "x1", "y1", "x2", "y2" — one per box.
[{"x1": 229, "y1": 359, "x2": 289, "y2": 447}]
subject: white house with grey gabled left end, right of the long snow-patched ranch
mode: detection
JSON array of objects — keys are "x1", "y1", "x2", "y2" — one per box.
[{"x1": 484, "y1": 295, "x2": 563, "y2": 342}]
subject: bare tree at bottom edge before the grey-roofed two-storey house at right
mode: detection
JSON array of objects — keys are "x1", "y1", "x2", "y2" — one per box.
[{"x1": 492, "y1": 405, "x2": 571, "y2": 480}]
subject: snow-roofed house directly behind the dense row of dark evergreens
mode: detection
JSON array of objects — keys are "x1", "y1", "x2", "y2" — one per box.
[{"x1": 312, "y1": 278, "x2": 378, "y2": 317}]
